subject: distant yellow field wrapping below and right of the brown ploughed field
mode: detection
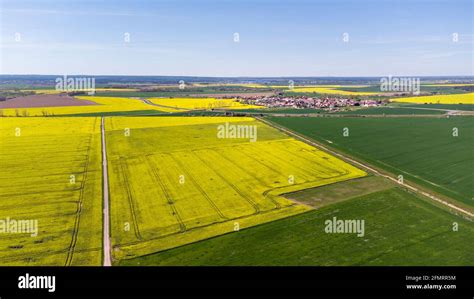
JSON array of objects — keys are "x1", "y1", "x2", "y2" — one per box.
[{"x1": 0, "y1": 96, "x2": 182, "y2": 116}]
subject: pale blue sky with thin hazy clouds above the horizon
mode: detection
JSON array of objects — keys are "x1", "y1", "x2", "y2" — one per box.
[{"x1": 0, "y1": 0, "x2": 474, "y2": 76}]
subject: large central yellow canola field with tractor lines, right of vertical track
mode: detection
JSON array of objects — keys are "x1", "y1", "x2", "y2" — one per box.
[{"x1": 105, "y1": 117, "x2": 366, "y2": 262}]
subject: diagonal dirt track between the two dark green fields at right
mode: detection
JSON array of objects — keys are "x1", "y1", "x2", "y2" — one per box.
[{"x1": 256, "y1": 117, "x2": 474, "y2": 218}]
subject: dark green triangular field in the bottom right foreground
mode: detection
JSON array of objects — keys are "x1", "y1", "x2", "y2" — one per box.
[{"x1": 120, "y1": 186, "x2": 474, "y2": 266}]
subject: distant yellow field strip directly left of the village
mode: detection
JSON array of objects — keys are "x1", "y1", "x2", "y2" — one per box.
[{"x1": 149, "y1": 98, "x2": 262, "y2": 110}]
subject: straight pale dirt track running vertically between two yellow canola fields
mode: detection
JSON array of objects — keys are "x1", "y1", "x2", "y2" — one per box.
[{"x1": 100, "y1": 116, "x2": 112, "y2": 266}]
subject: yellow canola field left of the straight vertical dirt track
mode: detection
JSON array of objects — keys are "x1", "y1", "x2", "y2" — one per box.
[{"x1": 0, "y1": 117, "x2": 102, "y2": 266}]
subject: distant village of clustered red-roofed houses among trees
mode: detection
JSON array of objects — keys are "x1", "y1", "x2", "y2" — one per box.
[{"x1": 238, "y1": 96, "x2": 385, "y2": 110}]
